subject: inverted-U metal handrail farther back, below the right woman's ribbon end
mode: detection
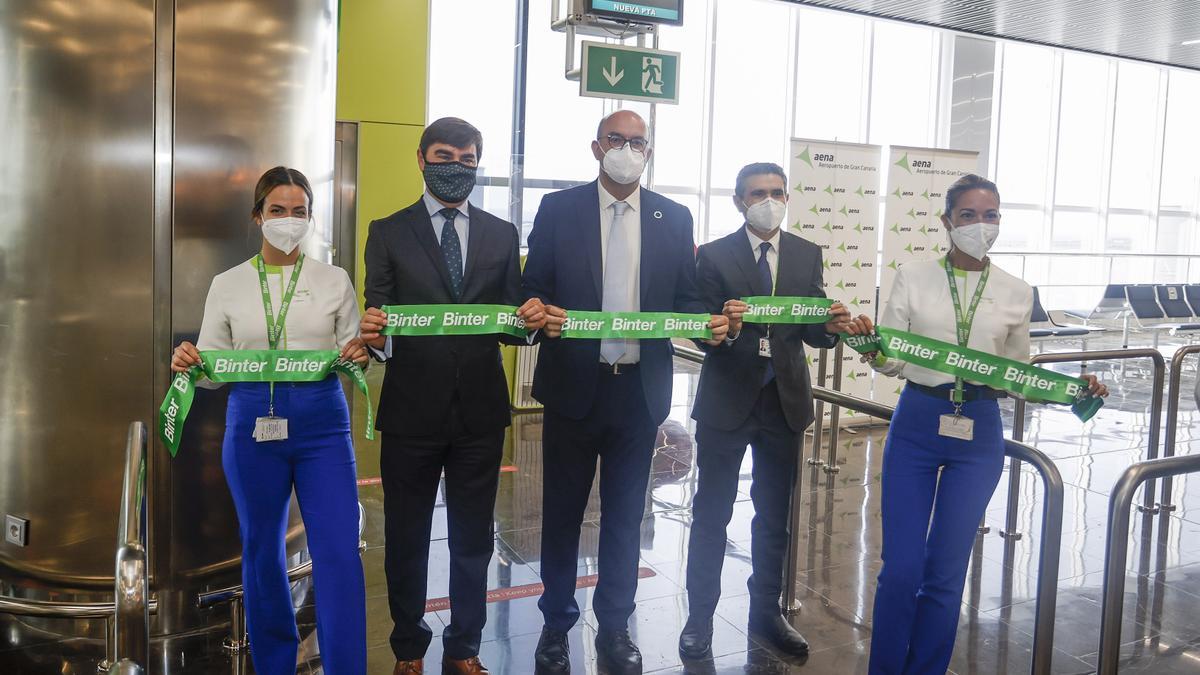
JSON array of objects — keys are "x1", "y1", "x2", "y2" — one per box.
[{"x1": 1000, "y1": 347, "x2": 1166, "y2": 539}]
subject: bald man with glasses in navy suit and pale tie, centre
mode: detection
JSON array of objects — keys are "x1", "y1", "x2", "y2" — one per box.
[{"x1": 524, "y1": 110, "x2": 727, "y2": 673}]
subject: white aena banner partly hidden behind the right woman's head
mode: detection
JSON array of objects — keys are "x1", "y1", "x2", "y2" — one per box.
[{"x1": 875, "y1": 145, "x2": 979, "y2": 405}]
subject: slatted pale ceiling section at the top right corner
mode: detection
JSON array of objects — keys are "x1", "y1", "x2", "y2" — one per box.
[{"x1": 792, "y1": 0, "x2": 1200, "y2": 70}]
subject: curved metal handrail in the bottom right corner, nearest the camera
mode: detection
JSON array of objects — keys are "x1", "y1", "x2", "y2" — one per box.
[{"x1": 1097, "y1": 455, "x2": 1200, "y2": 675}]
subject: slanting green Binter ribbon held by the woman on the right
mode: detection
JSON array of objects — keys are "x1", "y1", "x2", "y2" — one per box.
[{"x1": 841, "y1": 325, "x2": 1104, "y2": 422}]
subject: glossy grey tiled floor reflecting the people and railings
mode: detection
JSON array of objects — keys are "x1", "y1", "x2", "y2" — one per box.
[{"x1": 0, "y1": 340, "x2": 1200, "y2": 675}]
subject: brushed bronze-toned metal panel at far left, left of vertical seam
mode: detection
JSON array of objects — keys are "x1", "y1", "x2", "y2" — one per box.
[{"x1": 0, "y1": 0, "x2": 155, "y2": 586}]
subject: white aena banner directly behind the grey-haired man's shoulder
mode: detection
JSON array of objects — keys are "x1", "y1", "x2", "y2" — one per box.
[{"x1": 787, "y1": 138, "x2": 882, "y2": 419}]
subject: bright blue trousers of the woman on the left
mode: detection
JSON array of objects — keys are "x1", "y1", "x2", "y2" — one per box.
[{"x1": 222, "y1": 376, "x2": 367, "y2": 675}]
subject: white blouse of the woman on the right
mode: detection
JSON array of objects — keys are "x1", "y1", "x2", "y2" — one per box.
[{"x1": 871, "y1": 258, "x2": 1033, "y2": 387}]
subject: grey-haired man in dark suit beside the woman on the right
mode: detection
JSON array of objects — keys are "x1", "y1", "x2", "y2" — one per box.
[{"x1": 679, "y1": 163, "x2": 850, "y2": 658}]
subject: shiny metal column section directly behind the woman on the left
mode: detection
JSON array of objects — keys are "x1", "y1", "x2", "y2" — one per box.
[{"x1": 164, "y1": 0, "x2": 337, "y2": 586}]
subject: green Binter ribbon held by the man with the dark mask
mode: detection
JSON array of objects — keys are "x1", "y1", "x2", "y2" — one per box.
[{"x1": 382, "y1": 305, "x2": 528, "y2": 338}]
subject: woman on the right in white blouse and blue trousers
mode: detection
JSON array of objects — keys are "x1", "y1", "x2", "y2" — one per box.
[{"x1": 856, "y1": 175, "x2": 1108, "y2": 675}]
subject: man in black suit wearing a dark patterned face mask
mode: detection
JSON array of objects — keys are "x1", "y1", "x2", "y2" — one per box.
[{"x1": 361, "y1": 118, "x2": 545, "y2": 675}]
